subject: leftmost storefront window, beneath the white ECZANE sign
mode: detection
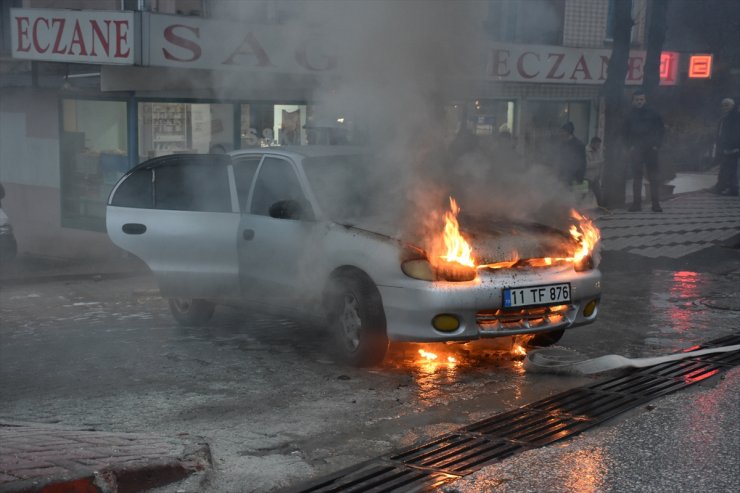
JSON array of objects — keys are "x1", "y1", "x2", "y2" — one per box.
[{"x1": 60, "y1": 99, "x2": 130, "y2": 230}]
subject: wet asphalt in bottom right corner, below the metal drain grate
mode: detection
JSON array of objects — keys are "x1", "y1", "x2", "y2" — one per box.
[{"x1": 441, "y1": 368, "x2": 740, "y2": 493}]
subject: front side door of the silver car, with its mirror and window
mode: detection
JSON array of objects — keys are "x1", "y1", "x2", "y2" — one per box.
[{"x1": 238, "y1": 155, "x2": 318, "y2": 302}]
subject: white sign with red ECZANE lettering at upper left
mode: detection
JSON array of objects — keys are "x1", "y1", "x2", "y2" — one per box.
[{"x1": 10, "y1": 9, "x2": 136, "y2": 65}]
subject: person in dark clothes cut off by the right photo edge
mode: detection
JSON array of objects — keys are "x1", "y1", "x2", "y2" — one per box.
[{"x1": 710, "y1": 98, "x2": 740, "y2": 196}]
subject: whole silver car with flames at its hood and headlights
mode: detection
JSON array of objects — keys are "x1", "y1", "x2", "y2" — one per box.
[{"x1": 106, "y1": 146, "x2": 601, "y2": 366}]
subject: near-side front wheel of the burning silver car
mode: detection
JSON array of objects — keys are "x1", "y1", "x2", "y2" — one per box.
[{"x1": 327, "y1": 275, "x2": 388, "y2": 367}]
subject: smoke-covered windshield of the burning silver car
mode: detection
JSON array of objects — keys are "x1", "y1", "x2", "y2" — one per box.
[{"x1": 303, "y1": 154, "x2": 373, "y2": 224}]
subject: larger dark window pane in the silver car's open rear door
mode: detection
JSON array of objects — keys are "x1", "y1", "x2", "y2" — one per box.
[{"x1": 154, "y1": 159, "x2": 231, "y2": 212}]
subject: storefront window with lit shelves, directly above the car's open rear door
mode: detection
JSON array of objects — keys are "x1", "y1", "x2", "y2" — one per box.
[{"x1": 139, "y1": 102, "x2": 234, "y2": 162}]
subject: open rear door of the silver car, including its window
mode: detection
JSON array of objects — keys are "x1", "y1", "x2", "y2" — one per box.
[{"x1": 106, "y1": 155, "x2": 240, "y2": 299}]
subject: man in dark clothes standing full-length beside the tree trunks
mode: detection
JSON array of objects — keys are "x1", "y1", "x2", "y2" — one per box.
[{"x1": 622, "y1": 90, "x2": 665, "y2": 212}]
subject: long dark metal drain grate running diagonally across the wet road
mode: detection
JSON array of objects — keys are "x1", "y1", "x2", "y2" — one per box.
[{"x1": 286, "y1": 334, "x2": 740, "y2": 493}]
